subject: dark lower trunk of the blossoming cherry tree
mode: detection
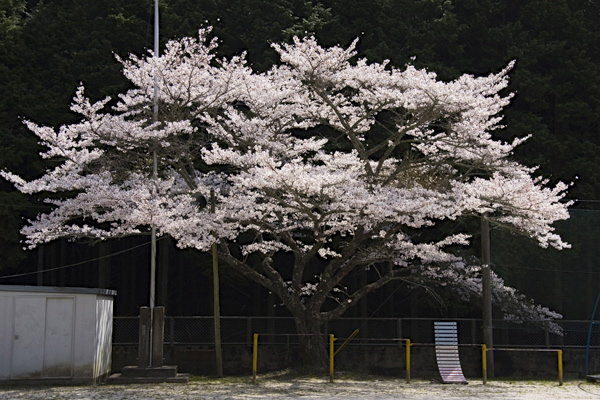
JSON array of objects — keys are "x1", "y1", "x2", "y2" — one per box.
[{"x1": 293, "y1": 312, "x2": 328, "y2": 372}]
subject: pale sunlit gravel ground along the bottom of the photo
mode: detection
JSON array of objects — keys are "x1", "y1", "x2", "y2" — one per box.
[{"x1": 0, "y1": 378, "x2": 600, "y2": 400}]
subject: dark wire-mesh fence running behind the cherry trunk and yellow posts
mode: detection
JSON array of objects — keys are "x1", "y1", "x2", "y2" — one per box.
[{"x1": 113, "y1": 316, "x2": 600, "y2": 349}]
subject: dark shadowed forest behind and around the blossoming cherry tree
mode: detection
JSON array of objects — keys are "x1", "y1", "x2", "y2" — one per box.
[{"x1": 0, "y1": 0, "x2": 600, "y2": 319}]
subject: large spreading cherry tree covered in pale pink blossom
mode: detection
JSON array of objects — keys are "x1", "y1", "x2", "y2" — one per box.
[{"x1": 2, "y1": 30, "x2": 569, "y2": 364}]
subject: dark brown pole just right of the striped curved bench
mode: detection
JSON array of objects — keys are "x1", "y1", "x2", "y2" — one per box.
[{"x1": 481, "y1": 219, "x2": 494, "y2": 378}]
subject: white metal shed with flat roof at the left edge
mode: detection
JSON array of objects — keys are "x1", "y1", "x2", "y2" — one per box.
[{"x1": 0, "y1": 285, "x2": 116, "y2": 384}]
